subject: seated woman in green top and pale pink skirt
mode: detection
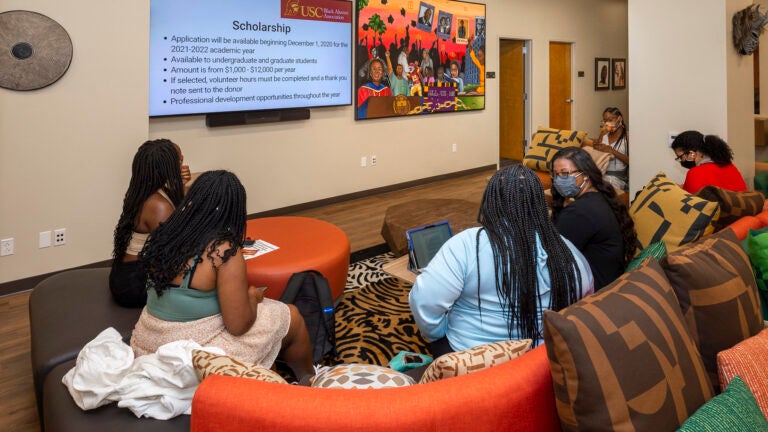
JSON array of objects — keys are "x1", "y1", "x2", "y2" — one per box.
[{"x1": 131, "y1": 171, "x2": 313, "y2": 379}]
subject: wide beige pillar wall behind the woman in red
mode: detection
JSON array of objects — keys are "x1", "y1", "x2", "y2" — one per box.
[{"x1": 628, "y1": 0, "x2": 754, "y2": 193}]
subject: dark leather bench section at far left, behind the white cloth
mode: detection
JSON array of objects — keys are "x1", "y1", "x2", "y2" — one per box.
[{"x1": 29, "y1": 268, "x2": 141, "y2": 422}]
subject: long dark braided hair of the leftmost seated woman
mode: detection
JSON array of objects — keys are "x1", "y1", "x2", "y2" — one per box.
[{"x1": 112, "y1": 139, "x2": 184, "y2": 265}]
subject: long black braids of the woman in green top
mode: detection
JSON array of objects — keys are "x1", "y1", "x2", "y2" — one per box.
[{"x1": 139, "y1": 171, "x2": 246, "y2": 295}]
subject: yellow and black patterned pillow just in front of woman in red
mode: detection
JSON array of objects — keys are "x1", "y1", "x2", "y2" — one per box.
[{"x1": 629, "y1": 172, "x2": 720, "y2": 252}]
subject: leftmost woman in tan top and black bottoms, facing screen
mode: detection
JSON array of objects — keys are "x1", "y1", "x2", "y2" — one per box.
[{"x1": 109, "y1": 139, "x2": 191, "y2": 308}]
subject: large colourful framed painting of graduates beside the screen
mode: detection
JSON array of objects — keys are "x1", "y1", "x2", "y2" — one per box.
[{"x1": 354, "y1": 0, "x2": 486, "y2": 120}]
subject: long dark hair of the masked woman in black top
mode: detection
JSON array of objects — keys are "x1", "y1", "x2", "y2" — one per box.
[{"x1": 550, "y1": 147, "x2": 637, "y2": 267}]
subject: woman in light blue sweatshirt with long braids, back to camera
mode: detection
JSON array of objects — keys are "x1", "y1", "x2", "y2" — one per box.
[{"x1": 409, "y1": 165, "x2": 593, "y2": 356}]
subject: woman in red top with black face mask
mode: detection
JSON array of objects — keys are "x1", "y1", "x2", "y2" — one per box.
[{"x1": 672, "y1": 130, "x2": 747, "y2": 194}]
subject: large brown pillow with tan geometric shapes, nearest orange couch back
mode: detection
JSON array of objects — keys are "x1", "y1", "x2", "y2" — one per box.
[{"x1": 544, "y1": 260, "x2": 713, "y2": 431}]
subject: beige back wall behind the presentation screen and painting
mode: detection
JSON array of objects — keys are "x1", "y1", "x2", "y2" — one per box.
[{"x1": 0, "y1": 0, "x2": 624, "y2": 283}]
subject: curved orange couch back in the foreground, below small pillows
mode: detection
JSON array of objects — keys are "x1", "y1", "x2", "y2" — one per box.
[{"x1": 191, "y1": 345, "x2": 560, "y2": 432}]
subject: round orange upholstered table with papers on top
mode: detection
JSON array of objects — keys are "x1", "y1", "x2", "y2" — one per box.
[{"x1": 245, "y1": 216, "x2": 350, "y2": 300}]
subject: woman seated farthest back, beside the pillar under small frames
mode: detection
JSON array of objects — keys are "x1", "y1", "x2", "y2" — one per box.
[{"x1": 585, "y1": 107, "x2": 629, "y2": 192}]
